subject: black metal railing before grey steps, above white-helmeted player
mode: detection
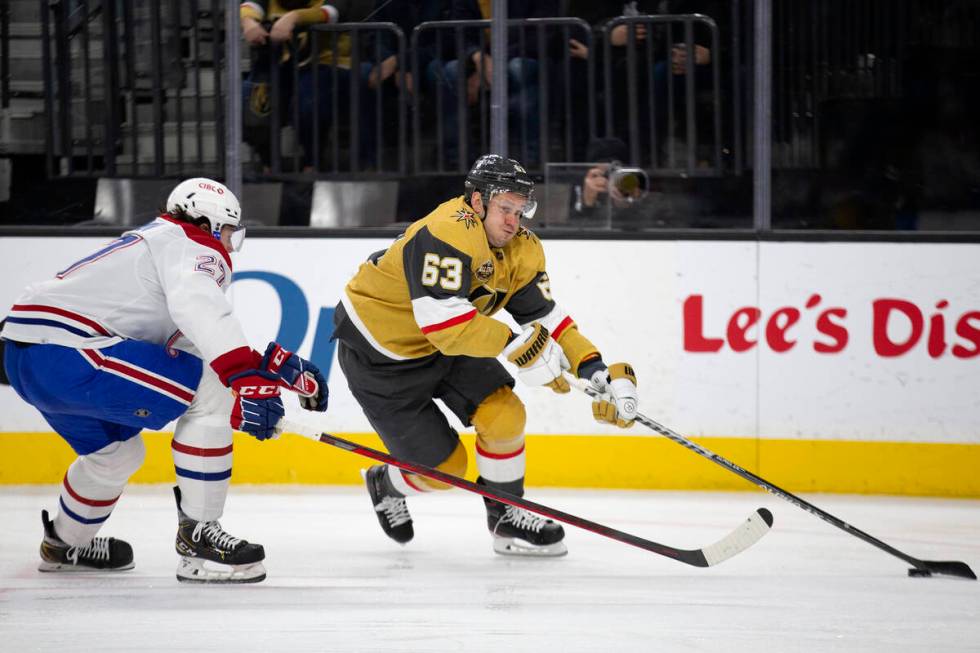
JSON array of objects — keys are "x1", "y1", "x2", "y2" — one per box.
[{"x1": 41, "y1": 0, "x2": 225, "y2": 178}]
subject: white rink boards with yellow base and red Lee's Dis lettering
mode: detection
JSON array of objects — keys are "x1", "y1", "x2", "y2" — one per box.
[{"x1": 0, "y1": 237, "x2": 980, "y2": 497}]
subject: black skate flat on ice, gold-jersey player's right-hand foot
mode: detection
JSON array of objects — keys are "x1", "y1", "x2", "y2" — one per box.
[{"x1": 483, "y1": 497, "x2": 568, "y2": 556}]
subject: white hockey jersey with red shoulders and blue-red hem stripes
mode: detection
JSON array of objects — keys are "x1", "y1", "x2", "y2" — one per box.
[{"x1": 0, "y1": 215, "x2": 248, "y2": 374}]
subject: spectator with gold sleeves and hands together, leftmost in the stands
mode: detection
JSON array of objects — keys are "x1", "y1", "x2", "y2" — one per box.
[{"x1": 240, "y1": 0, "x2": 376, "y2": 171}]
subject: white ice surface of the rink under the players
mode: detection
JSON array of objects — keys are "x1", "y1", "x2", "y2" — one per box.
[{"x1": 0, "y1": 485, "x2": 980, "y2": 653}]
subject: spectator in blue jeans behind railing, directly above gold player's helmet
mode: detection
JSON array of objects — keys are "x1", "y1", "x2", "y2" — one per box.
[{"x1": 427, "y1": 0, "x2": 561, "y2": 169}]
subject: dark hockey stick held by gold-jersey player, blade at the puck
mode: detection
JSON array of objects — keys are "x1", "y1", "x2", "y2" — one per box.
[{"x1": 568, "y1": 376, "x2": 977, "y2": 580}]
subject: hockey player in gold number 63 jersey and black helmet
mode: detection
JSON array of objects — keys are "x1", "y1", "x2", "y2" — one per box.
[{"x1": 334, "y1": 154, "x2": 637, "y2": 555}]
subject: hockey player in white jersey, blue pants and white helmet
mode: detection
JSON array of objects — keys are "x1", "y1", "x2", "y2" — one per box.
[{"x1": 0, "y1": 178, "x2": 327, "y2": 583}]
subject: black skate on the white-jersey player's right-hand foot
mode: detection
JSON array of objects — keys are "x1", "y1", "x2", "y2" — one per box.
[{"x1": 174, "y1": 487, "x2": 265, "y2": 583}]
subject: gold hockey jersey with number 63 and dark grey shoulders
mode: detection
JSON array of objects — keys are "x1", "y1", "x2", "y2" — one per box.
[{"x1": 337, "y1": 196, "x2": 598, "y2": 373}]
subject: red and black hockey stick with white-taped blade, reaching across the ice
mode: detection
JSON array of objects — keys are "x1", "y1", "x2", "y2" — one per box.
[{"x1": 276, "y1": 418, "x2": 772, "y2": 567}]
